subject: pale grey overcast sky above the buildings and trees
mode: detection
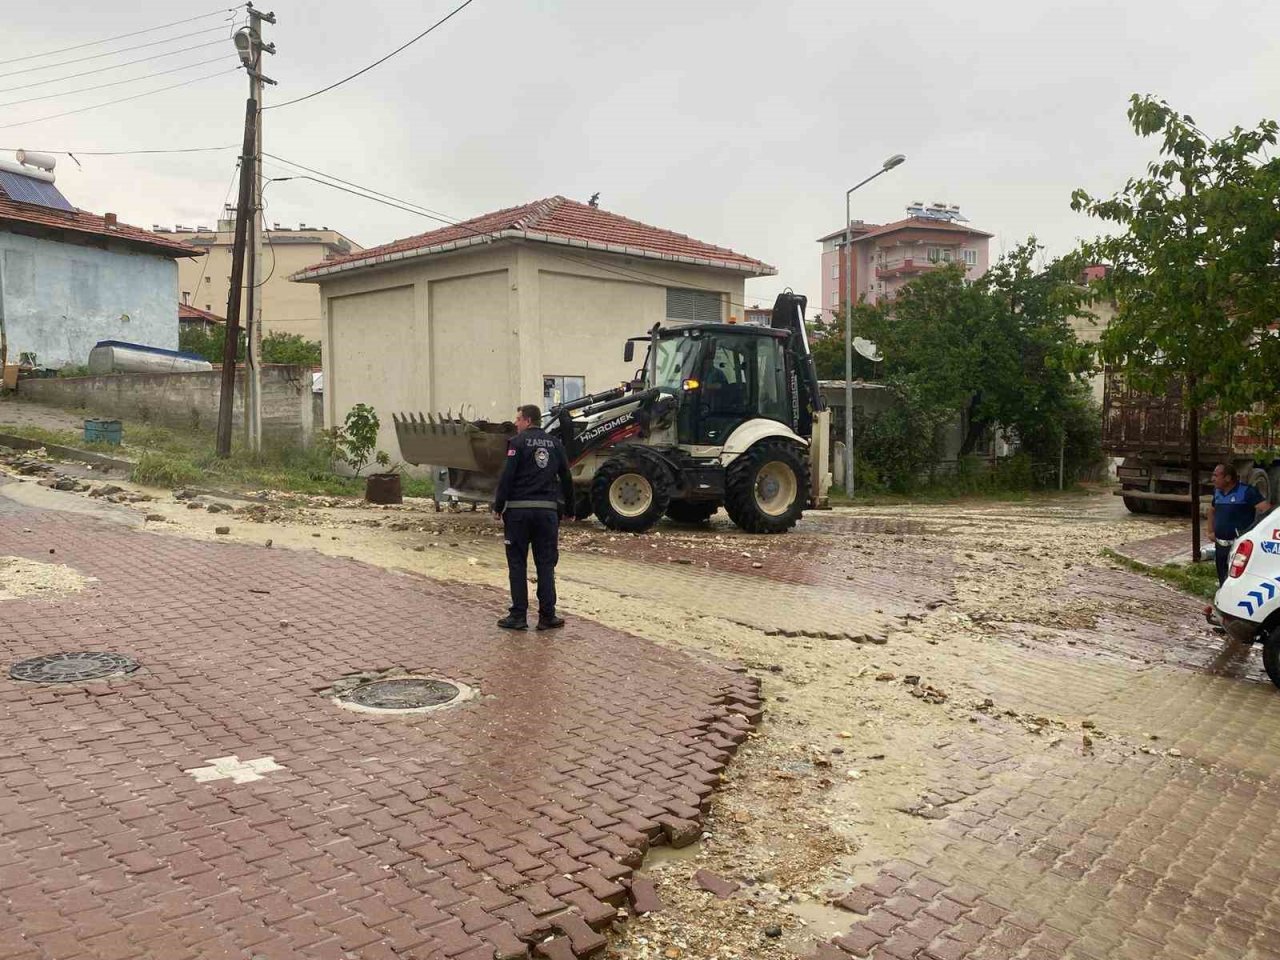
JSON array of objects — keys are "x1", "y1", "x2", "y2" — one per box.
[{"x1": 0, "y1": 0, "x2": 1280, "y2": 312}]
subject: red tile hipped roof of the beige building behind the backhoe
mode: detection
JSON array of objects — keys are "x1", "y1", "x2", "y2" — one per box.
[{"x1": 293, "y1": 197, "x2": 777, "y2": 280}]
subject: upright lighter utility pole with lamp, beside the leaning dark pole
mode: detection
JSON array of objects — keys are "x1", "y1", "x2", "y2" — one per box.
[{"x1": 236, "y1": 3, "x2": 275, "y2": 452}]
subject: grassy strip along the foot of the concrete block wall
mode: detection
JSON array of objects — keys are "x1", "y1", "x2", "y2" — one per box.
[{"x1": 0, "y1": 424, "x2": 433, "y2": 497}]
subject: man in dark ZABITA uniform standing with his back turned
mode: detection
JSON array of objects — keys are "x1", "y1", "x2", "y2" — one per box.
[{"x1": 493, "y1": 403, "x2": 573, "y2": 630}]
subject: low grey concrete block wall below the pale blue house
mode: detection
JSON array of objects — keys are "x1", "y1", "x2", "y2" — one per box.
[{"x1": 18, "y1": 364, "x2": 320, "y2": 445}]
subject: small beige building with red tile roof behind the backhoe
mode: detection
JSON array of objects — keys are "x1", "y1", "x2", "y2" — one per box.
[{"x1": 293, "y1": 197, "x2": 776, "y2": 458}]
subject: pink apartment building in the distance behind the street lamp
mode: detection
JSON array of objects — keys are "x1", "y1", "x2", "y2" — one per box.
[{"x1": 818, "y1": 204, "x2": 992, "y2": 316}]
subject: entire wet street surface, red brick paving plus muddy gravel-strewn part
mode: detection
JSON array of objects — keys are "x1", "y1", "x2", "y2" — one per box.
[{"x1": 0, "y1": 476, "x2": 1280, "y2": 960}]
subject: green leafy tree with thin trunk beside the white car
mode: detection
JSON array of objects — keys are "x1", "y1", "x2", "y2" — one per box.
[{"x1": 1071, "y1": 95, "x2": 1280, "y2": 556}]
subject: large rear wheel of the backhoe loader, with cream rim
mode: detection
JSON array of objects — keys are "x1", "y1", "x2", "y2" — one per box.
[{"x1": 724, "y1": 439, "x2": 809, "y2": 534}]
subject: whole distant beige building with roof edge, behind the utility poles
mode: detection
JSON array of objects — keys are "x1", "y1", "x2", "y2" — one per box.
[{"x1": 170, "y1": 217, "x2": 361, "y2": 340}]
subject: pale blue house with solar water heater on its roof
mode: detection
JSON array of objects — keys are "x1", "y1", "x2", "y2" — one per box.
[{"x1": 0, "y1": 157, "x2": 197, "y2": 369}]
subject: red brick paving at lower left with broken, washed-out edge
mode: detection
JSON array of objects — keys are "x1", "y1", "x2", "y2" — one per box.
[{"x1": 0, "y1": 498, "x2": 759, "y2": 960}]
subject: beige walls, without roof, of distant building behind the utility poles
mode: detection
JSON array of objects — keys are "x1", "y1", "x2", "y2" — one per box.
[{"x1": 174, "y1": 230, "x2": 360, "y2": 340}]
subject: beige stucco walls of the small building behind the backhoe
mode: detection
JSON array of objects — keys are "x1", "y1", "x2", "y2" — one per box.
[{"x1": 308, "y1": 243, "x2": 745, "y2": 458}]
